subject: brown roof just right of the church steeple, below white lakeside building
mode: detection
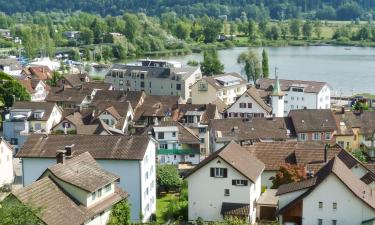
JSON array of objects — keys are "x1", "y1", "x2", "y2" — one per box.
[{"x1": 288, "y1": 109, "x2": 337, "y2": 133}]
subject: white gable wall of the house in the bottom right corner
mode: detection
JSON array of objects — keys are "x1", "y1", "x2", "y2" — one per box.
[{"x1": 302, "y1": 174, "x2": 375, "y2": 225}]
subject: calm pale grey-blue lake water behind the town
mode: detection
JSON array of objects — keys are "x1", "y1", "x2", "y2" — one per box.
[{"x1": 94, "y1": 46, "x2": 375, "y2": 94}]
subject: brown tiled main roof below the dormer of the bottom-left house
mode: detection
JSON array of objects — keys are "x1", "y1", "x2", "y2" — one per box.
[{"x1": 12, "y1": 177, "x2": 128, "y2": 225}]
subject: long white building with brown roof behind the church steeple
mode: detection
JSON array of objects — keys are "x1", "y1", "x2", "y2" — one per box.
[{"x1": 256, "y1": 78, "x2": 331, "y2": 116}]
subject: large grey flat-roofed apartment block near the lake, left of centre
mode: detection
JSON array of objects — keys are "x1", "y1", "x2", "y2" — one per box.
[{"x1": 105, "y1": 59, "x2": 202, "y2": 101}]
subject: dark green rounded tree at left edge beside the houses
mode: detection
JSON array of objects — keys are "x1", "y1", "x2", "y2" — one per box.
[{"x1": 0, "y1": 80, "x2": 31, "y2": 107}]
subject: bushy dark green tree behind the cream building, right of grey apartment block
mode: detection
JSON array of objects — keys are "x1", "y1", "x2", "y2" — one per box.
[{"x1": 201, "y1": 48, "x2": 224, "y2": 76}]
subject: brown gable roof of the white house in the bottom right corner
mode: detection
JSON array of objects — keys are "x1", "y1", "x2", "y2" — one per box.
[{"x1": 276, "y1": 157, "x2": 375, "y2": 213}]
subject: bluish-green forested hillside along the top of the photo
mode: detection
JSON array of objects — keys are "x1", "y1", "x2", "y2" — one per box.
[{"x1": 0, "y1": 0, "x2": 375, "y2": 20}]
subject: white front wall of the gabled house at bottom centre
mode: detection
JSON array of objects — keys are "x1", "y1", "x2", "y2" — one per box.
[{"x1": 187, "y1": 158, "x2": 260, "y2": 221}]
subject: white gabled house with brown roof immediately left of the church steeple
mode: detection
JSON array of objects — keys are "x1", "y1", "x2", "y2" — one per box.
[{"x1": 224, "y1": 87, "x2": 272, "y2": 118}]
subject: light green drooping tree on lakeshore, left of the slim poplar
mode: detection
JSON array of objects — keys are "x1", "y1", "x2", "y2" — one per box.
[{"x1": 237, "y1": 49, "x2": 262, "y2": 84}]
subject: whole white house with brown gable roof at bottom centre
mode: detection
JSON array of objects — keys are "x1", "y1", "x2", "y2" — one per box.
[{"x1": 186, "y1": 141, "x2": 264, "y2": 224}]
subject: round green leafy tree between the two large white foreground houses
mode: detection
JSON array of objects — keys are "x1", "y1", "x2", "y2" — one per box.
[{"x1": 156, "y1": 164, "x2": 182, "y2": 192}]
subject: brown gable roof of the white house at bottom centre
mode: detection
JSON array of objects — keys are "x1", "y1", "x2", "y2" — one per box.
[{"x1": 186, "y1": 141, "x2": 265, "y2": 183}]
